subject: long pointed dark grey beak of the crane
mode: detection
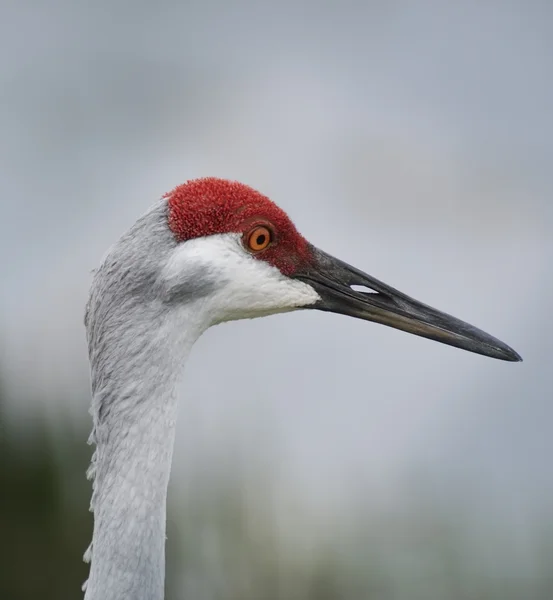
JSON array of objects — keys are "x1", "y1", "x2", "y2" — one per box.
[{"x1": 295, "y1": 247, "x2": 522, "y2": 361}]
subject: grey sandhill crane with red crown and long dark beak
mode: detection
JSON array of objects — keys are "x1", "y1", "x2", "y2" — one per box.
[{"x1": 81, "y1": 178, "x2": 521, "y2": 600}]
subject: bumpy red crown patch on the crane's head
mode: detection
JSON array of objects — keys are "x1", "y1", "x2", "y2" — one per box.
[{"x1": 165, "y1": 177, "x2": 310, "y2": 275}]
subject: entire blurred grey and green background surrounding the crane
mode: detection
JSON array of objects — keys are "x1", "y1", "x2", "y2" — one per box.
[{"x1": 0, "y1": 0, "x2": 553, "y2": 600}]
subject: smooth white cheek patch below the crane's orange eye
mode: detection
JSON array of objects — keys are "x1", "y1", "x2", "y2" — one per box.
[{"x1": 158, "y1": 233, "x2": 320, "y2": 322}]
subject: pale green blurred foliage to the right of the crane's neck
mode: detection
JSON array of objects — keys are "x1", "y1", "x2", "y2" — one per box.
[{"x1": 170, "y1": 473, "x2": 553, "y2": 600}]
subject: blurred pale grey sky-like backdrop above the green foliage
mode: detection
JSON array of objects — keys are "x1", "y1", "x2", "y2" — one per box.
[{"x1": 0, "y1": 0, "x2": 553, "y2": 552}]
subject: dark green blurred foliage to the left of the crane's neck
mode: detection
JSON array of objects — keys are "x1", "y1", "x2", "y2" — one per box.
[{"x1": 0, "y1": 391, "x2": 92, "y2": 600}]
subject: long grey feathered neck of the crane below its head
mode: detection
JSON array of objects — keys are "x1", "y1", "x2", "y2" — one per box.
[{"x1": 85, "y1": 290, "x2": 201, "y2": 600}]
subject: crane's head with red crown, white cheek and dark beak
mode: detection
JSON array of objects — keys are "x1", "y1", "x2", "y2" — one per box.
[{"x1": 163, "y1": 178, "x2": 522, "y2": 361}]
